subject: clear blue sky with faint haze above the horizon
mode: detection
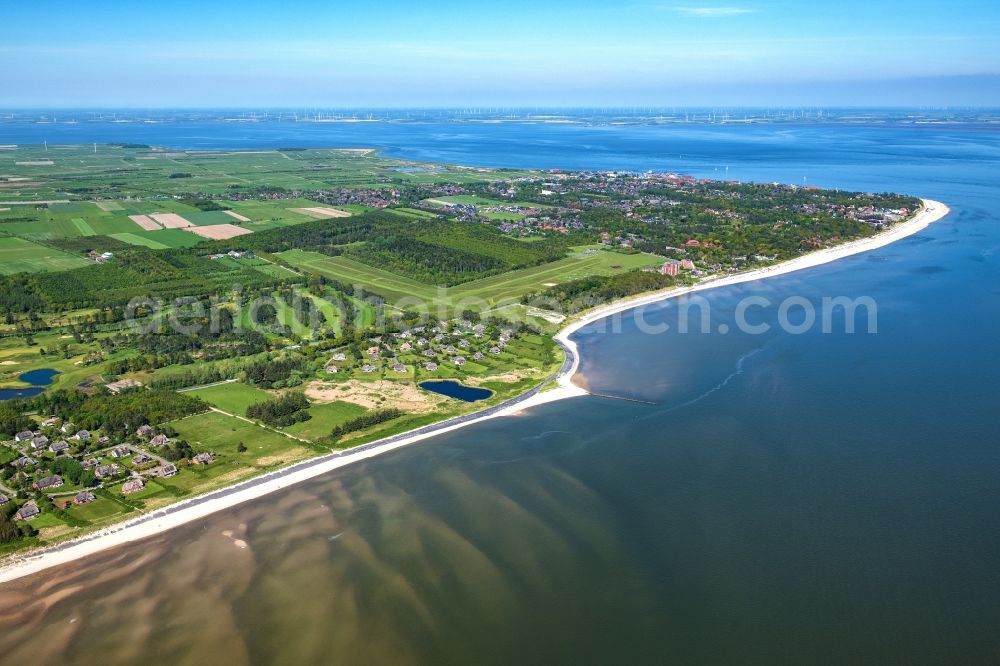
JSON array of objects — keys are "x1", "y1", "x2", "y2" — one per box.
[{"x1": 0, "y1": 0, "x2": 1000, "y2": 108}]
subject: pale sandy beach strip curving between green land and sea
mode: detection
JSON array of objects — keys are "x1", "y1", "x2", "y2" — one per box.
[{"x1": 0, "y1": 199, "x2": 950, "y2": 583}]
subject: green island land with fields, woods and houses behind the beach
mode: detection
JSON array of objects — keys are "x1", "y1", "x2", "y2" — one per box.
[{"x1": 0, "y1": 144, "x2": 920, "y2": 554}]
